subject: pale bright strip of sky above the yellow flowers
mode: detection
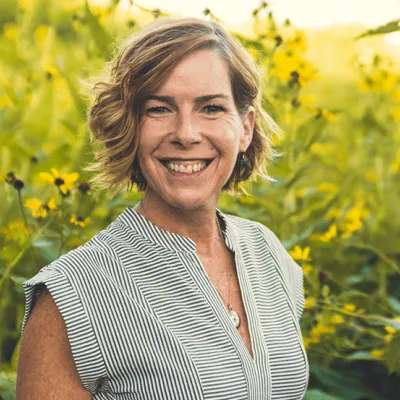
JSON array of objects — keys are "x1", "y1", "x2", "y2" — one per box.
[{"x1": 122, "y1": 0, "x2": 400, "y2": 46}]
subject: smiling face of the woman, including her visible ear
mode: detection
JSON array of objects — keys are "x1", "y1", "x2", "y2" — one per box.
[{"x1": 138, "y1": 50, "x2": 254, "y2": 210}]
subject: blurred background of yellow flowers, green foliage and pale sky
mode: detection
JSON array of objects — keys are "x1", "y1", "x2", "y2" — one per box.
[{"x1": 0, "y1": 0, "x2": 400, "y2": 400}]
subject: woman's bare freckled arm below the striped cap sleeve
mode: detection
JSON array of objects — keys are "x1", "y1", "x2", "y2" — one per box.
[{"x1": 16, "y1": 289, "x2": 92, "y2": 400}]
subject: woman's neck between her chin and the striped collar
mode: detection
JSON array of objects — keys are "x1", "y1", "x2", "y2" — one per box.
[{"x1": 135, "y1": 191, "x2": 223, "y2": 256}]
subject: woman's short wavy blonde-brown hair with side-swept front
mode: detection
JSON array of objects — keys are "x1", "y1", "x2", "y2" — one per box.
[{"x1": 84, "y1": 18, "x2": 281, "y2": 198}]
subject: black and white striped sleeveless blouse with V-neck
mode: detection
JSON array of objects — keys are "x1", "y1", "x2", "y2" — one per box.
[{"x1": 22, "y1": 207, "x2": 309, "y2": 400}]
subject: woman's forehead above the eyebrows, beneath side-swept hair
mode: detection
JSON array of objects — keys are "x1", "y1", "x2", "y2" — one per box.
[{"x1": 157, "y1": 50, "x2": 231, "y2": 97}]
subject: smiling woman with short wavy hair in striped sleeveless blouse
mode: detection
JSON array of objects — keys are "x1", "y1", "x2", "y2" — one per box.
[{"x1": 17, "y1": 19, "x2": 309, "y2": 400}]
